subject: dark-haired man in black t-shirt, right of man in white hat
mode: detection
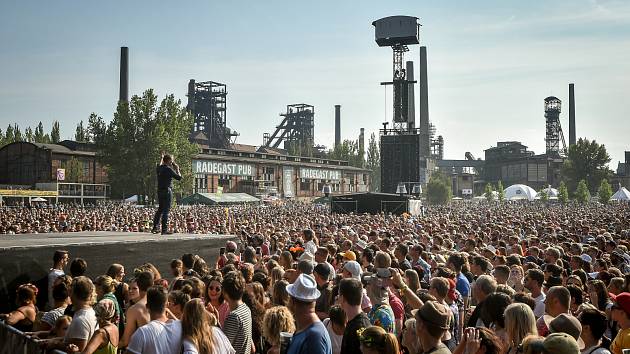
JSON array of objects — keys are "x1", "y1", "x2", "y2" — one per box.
[{"x1": 338, "y1": 278, "x2": 372, "y2": 354}]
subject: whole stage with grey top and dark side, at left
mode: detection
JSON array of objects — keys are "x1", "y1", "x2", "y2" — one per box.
[{"x1": 0, "y1": 231, "x2": 236, "y2": 313}]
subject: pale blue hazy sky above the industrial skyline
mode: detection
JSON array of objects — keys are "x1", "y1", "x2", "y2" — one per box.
[{"x1": 0, "y1": 0, "x2": 630, "y2": 169}]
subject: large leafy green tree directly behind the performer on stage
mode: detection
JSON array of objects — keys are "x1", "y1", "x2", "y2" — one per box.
[{"x1": 102, "y1": 89, "x2": 199, "y2": 201}]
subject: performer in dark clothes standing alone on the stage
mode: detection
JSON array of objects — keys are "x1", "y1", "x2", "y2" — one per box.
[{"x1": 151, "y1": 154, "x2": 182, "y2": 235}]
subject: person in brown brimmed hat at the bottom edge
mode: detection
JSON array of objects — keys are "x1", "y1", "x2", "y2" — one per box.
[{"x1": 414, "y1": 301, "x2": 451, "y2": 354}]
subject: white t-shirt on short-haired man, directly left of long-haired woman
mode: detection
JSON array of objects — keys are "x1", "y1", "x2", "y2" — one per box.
[{"x1": 127, "y1": 320, "x2": 182, "y2": 354}]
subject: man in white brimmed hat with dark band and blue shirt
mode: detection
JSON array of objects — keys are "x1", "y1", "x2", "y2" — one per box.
[{"x1": 287, "y1": 274, "x2": 332, "y2": 354}]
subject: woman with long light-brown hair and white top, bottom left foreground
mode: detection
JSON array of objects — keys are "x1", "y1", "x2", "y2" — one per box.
[{"x1": 182, "y1": 299, "x2": 236, "y2": 354}]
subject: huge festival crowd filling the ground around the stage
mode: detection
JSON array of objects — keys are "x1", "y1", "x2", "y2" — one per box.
[{"x1": 0, "y1": 203, "x2": 630, "y2": 354}]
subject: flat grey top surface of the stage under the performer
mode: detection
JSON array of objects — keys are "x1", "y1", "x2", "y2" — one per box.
[{"x1": 0, "y1": 231, "x2": 234, "y2": 252}]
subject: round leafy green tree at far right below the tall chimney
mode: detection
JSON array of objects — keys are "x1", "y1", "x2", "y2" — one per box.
[{"x1": 562, "y1": 138, "x2": 612, "y2": 194}]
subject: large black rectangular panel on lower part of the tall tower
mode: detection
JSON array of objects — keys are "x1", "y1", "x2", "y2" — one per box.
[{"x1": 381, "y1": 134, "x2": 420, "y2": 193}]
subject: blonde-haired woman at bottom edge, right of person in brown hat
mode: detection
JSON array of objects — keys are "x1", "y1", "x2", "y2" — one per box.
[{"x1": 504, "y1": 302, "x2": 538, "y2": 354}]
